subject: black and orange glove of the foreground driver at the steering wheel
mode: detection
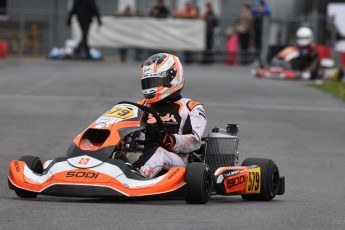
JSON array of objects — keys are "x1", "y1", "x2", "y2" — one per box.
[{"x1": 146, "y1": 124, "x2": 176, "y2": 151}]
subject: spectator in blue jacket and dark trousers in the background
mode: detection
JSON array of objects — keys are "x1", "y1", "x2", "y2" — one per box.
[{"x1": 252, "y1": 1, "x2": 271, "y2": 50}]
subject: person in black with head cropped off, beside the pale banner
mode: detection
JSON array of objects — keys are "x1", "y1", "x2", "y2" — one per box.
[{"x1": 66, "y1": 0, "x2": 102, "y2": 59}]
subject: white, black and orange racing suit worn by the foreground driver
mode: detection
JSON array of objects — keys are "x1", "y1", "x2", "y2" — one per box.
[{"x1": 133, "y1": 96, "x2": 207, "y2": 178}]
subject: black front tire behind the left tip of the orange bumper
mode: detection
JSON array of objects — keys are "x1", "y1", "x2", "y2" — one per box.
[{"x1": 15, "y1": 156, "x2": 43, "y2": 198}]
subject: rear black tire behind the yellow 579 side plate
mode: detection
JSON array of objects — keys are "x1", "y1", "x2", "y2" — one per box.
[{"x1": 241, "y1": 158, "x2": 280, "y2": 201}]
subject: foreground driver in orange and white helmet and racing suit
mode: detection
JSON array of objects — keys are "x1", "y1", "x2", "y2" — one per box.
[{"x1": 133, "y1": 53, "x2": 207, "y2": 178}]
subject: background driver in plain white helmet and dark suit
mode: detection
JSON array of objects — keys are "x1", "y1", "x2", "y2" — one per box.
[{"x1": 291, "y1": 27, "x2": 318, "y2": 79}]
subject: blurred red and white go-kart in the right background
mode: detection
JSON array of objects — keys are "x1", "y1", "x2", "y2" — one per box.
[{"x1": 252, "y1": 46, "x2": 344, "y2": 81}]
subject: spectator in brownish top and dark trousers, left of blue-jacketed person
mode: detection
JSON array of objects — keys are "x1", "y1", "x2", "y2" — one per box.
[{"x1": 235, "y1": 4, "x2": 252, "y2": 64}]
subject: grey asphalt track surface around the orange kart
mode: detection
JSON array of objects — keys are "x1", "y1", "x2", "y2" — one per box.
[{"x1": 0, "y1": 59, "x2": 345, "y2": 230}]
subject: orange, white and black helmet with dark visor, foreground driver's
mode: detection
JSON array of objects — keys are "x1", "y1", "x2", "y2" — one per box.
[{"x1": 141, "y1": 53, "x2": 184, "y2": 104}]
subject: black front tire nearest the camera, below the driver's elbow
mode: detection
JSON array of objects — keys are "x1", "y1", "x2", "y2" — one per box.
[{"x1": 185, "y1": 162, "x2": 212, "y2": 204}]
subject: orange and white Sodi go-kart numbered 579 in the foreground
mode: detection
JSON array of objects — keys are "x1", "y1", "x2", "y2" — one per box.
[{"x1": 8, "y1": 102, "x2": 285, "y2": 204}]
